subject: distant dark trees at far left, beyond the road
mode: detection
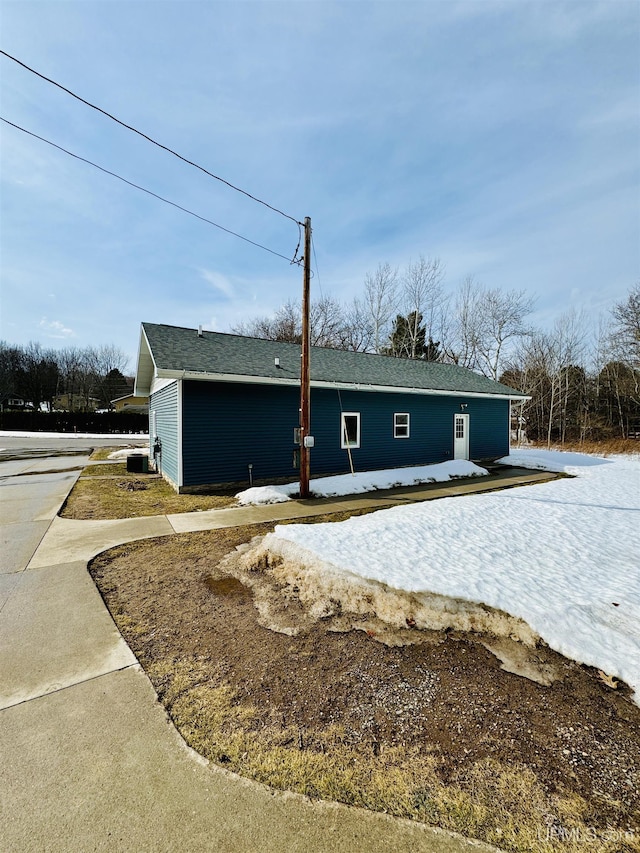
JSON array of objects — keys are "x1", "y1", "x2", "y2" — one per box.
[{"x1": 0, "y1": 341, "x2": 132, "y2": 412}]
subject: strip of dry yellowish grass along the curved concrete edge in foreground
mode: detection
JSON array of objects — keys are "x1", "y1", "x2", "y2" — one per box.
[{"x1": 156, "y1": 660, "x2": 640, "y2": 853}]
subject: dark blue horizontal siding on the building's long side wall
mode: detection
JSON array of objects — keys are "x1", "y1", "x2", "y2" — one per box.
[{"x1": 180, "y1": 381, "x2": 509, "y2": 486}]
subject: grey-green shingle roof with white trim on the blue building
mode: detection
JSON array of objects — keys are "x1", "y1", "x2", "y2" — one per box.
[{"x1": 135, "y1": 323, "x2": 526, "y2": 399}]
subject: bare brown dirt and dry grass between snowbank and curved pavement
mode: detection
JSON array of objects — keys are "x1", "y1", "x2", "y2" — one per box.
[{"x1": 91, "y1": 525, "x2": 640, "y2": 851}]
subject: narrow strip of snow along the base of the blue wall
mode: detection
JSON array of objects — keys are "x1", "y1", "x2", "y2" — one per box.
[{"x1": 236, "y1": 459, "x2": 487, "y2": 506}]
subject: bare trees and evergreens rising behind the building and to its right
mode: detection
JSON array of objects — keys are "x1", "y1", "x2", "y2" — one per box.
[{"x1": 232, "y1": 257, "x2": 640, "y2": 443}]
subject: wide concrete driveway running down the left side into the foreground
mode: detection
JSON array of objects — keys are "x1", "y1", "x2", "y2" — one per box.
[{"x1": 0, "y1": 434, "x2": 500, "y2": 853}]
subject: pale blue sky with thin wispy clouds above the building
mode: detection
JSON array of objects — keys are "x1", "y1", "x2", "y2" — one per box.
[{"x1": 0, "y1": 0, "x2": 640, "y2": 369}]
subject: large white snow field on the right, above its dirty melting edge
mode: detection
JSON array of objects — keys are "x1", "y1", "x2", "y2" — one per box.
[{"x1": 264, "y1": 450, "x2": 640, "y2": 704}]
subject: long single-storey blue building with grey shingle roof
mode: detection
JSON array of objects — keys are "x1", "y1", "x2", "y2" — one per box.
[{"x1": 135, "y1": 323, "x2": 528, "y2": 492}]
